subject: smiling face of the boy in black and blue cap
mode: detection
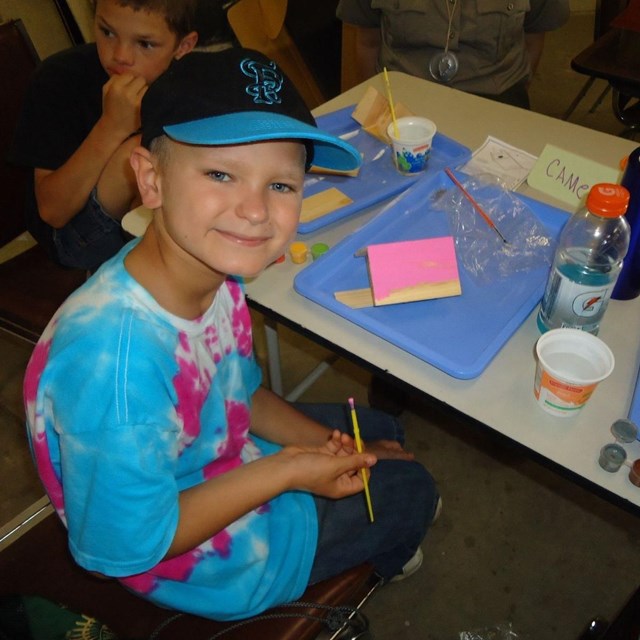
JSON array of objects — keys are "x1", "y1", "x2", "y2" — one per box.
[{"x1": 149, "y1": 141, "x2": 305, "y2": 277}]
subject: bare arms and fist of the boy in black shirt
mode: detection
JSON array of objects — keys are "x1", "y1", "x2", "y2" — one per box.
[{"x1": 34, "y1": 74, "x2": 147, "y2": 228}]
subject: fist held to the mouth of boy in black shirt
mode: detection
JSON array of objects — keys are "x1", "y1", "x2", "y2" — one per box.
[{"x1": 102, "y1": 73, "x2": 149, "y2": 140}]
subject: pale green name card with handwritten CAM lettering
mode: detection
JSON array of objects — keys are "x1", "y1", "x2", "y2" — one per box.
[{"x1": 527, "y1": 144, "x2": 620, "y2": 211}]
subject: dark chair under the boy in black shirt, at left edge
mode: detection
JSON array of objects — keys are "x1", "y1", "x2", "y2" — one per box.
[{"x1": 0, "y1": 20, "x2": 86, "y2": 342}]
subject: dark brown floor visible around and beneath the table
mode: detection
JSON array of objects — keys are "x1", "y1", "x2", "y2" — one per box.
[{"x1": 0, "y1": 8, "x2": 640, "y2": 640}]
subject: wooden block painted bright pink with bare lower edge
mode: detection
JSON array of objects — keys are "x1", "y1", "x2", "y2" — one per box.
[{"x1": 367, "y1": 236, "x2": 462, "y2": 305}]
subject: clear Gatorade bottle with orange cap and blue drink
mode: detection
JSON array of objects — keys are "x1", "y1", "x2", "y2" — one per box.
[{"x1": 538, "y1": 183, "x2": 630, "y2": 335}]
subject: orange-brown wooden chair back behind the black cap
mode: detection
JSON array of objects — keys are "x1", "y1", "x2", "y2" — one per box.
[{"x1": 227, "y1": 0, "x2": 325, "y2": 109}]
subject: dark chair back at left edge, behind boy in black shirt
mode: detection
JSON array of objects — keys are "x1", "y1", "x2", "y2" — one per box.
[{"x1": 0, "y1": 20, "x2": 39, "y2": 246}]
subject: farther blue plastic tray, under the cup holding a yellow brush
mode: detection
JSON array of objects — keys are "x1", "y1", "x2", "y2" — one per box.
[{"x1": 298, "y1": 105, "x2": 471, "y2": 233}]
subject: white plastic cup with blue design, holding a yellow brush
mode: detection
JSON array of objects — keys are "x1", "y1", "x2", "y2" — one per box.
[{"x1": 387, "y1": 116, "x2": 436, "y2": 176}]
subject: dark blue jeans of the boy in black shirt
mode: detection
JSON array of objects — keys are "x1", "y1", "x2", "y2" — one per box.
[{"x1": 52, "y1": 189, "x2": 127, "y2": 271}]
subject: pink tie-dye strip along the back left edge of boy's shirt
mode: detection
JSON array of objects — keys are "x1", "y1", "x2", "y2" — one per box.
[{"x1": 23, "y1": 340, "x2": 64, "y2": 520}]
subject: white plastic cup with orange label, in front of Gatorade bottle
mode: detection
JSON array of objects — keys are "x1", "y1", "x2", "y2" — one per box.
[{"x1": 533, "y1": 329, "x2": 615, "y2": 418}]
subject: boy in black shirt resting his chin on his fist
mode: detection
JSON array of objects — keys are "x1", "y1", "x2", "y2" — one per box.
[{"x1": 11, "y1": 0, "x2": 197, "y2": 271}]
